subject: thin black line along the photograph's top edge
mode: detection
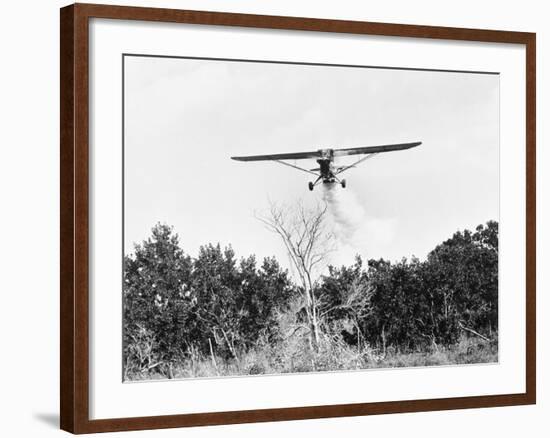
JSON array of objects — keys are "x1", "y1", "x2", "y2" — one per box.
[{"x1": 122, "y1": 53, "x2": 500, "y2": 75}]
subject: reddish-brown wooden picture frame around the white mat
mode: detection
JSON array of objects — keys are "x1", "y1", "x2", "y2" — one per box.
[{"x1": 60, "y1": 4, "x2": 536, "y2": 433}]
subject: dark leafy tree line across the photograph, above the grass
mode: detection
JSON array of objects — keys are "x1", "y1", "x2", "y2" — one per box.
[{"x1": 123, "y1": 219, "x2": 498, "y2": 372}]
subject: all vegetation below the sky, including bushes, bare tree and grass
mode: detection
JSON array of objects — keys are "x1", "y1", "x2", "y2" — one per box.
[{"x1": 123, "y1": 219, "x2": 498, "y2": 380}]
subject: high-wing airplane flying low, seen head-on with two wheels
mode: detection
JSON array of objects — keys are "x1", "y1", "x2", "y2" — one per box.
[{"x1": 231, "y1": 141, "x2": 422, "y2": 190}]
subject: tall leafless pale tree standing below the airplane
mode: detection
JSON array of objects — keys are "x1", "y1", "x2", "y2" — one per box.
[{"x1": 256, "y1": 201, "x2": 334, "y2": 351}]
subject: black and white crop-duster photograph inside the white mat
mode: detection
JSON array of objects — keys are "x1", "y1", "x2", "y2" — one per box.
[{"x1": 121, "y1": 54, "x2": 500, "y2": 382}]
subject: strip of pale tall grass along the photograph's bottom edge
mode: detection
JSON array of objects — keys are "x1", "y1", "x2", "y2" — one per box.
[{"x1": 126, "y1": 336, "x2": 498, "y2": 380}]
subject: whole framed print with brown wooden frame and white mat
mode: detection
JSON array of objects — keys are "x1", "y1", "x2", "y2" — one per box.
[{"x1": 61, "y1": 4, "x2": 536, "y2": 433}]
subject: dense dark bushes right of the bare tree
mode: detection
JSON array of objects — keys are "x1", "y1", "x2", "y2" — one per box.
[{"x1": 318, "y1": 221, "x2": 498, "y2": 350}]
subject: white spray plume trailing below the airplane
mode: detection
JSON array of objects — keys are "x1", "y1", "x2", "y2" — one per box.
[{"x1": 322, "y1": 184, "x2": 395, "y2": 264}]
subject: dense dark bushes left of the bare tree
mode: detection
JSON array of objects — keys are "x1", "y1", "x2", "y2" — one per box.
[{"x1": 124, "y1": 225, "x2": 294, "y2": 370}]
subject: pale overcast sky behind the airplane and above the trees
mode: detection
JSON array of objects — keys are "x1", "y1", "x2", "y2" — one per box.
[{"x1": 125, "y1": 56, "x2": 499, "y2": 274}]
